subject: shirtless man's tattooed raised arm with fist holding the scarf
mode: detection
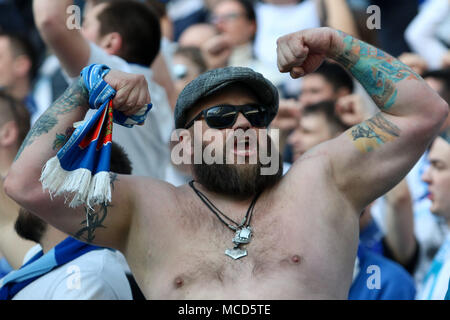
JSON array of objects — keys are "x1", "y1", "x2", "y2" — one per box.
[{"x1": 4, "y1": 70, "x2": 150, "y2": 250}]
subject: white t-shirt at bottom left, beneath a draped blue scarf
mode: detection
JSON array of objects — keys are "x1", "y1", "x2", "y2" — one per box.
[{"x1": 13, "y1": 245, "x2": 133, "y2": 300}]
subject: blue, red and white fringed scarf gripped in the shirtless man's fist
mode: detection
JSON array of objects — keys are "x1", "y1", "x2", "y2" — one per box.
[{"x1": 40, "y1": 64, "x2": 152, "y2": 208}]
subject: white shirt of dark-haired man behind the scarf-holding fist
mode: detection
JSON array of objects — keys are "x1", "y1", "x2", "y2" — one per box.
[{"x1": 72, "y1": 43, "x2": 174, "y2": 180}]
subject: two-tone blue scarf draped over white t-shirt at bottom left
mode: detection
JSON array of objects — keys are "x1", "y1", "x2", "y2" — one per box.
[{"x1": 0, "y1": 237, "x2": 102, "y2": 300}]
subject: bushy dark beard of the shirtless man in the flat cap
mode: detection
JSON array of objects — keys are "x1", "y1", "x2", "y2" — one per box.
[{"x1": 193, "y1": 142, "x2": 283, "y2": 199}]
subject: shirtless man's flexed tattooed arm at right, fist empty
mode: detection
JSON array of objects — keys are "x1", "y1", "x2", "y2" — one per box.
[{"x1": 277, "y1": 28, "x2": 448, "y2": 211}]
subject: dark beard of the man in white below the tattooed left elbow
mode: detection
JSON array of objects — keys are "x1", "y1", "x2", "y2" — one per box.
[{"x1": 14, "y1": 208, "x2": 47, "y2": 243}]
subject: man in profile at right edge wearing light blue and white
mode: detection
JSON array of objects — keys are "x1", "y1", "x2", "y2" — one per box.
[{"x1": 417, "y1": 137, "x2": 450, "y2": 300}]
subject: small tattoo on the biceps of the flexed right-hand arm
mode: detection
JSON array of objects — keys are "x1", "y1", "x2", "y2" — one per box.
[{"x1": 349, "y1": 113, "x2": 400, "y2": 153}]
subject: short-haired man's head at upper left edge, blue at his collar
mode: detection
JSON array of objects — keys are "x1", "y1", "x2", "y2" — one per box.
[{"x1": 0, "y1": 31, "x2": 38, "y2": 120}]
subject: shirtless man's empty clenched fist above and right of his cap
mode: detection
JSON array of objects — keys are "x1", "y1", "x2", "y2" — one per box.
[{"x1": 277, "y1": 28, "x2": 339, "y2": 79}]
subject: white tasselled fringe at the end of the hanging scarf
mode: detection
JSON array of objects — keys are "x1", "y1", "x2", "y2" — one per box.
[{"x1": 40, "y1": 156, "x2": 111, "y2": 209}]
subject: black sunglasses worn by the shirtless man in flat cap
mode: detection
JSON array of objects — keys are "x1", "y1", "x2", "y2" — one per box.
[{"x1": 185, "y1": 104, "x2": 270, "y2": 129}]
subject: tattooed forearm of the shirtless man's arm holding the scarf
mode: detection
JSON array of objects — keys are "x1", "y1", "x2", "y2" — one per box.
[{"x1": 14, "y1": 78, "x2": 88, "y2": 161}]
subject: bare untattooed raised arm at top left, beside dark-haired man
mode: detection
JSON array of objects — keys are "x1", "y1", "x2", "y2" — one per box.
[{"x1": 33, "y1": 0, "x2": 90, "y2": 77}]
